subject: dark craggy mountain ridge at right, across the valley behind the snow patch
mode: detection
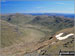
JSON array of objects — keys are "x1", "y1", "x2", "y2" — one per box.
[{"x1": 29, "y1": 15, "x2": 74, "y2": 33}]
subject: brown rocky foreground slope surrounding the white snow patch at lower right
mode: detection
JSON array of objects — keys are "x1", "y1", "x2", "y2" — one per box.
[{"x1": 40, "y1": 27, "x2": 75, "y2": 56}]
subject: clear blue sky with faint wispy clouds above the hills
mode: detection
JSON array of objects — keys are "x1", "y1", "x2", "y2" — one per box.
[{"x1": 1, "y1": 1, "x2": 74, "y2": 14}]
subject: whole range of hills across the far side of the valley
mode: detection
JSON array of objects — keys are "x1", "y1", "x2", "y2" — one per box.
[{"x1": 1, "y1": 13, "x2": 74, "y2": 36}]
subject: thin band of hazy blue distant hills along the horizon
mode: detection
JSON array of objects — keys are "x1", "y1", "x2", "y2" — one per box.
[{"x1": 24, "y1": 13, "x2": 74, "y2": 19}]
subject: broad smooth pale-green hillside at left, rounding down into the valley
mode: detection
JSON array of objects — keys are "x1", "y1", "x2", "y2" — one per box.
[{"x1": 1, "y1": 20, "x2": 45, "y2": 47}]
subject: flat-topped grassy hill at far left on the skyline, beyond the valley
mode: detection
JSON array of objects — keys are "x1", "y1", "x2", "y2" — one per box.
[{"x1": 1, "y1": 13, "x2": 35, "y2": 25}]
